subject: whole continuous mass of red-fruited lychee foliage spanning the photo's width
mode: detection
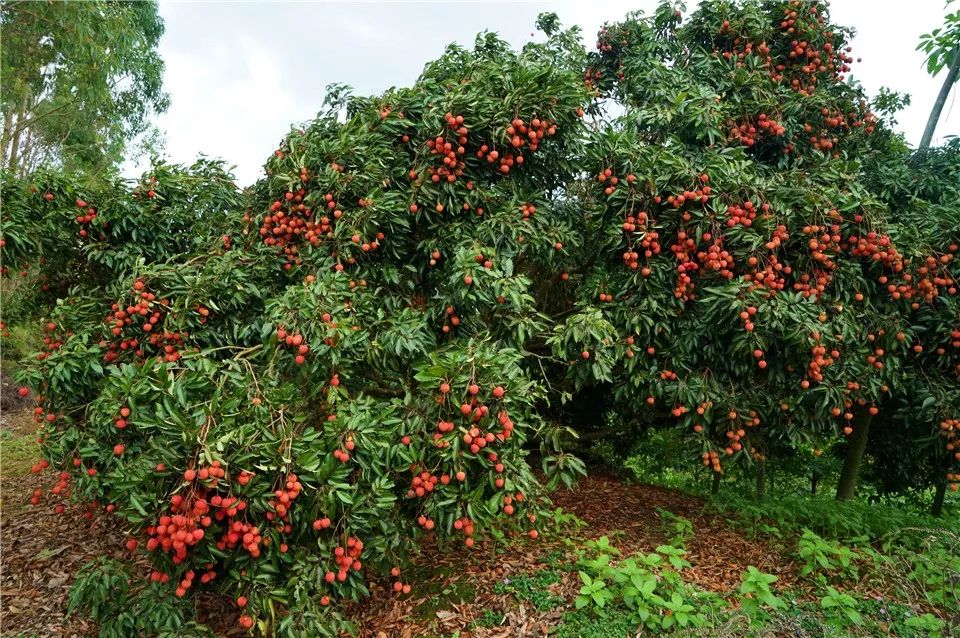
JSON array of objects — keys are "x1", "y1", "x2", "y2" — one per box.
[{"x1": 2, "y1": 1, "x2": 960, "y2": 635}]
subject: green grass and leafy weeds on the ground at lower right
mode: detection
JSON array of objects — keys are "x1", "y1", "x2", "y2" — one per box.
[{"x1": 472, "y1": 484, "x2": 960, "y2": 638}]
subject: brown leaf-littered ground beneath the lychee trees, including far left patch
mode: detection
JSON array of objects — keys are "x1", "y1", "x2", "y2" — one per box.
[{"x1": 0, "y1": 401, "x2": 808, "y2": 638}]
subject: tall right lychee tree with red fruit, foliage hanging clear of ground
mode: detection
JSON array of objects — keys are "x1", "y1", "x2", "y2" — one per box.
[{"x1": 551, "y1": 2, "x2": 960, "y2": 499}]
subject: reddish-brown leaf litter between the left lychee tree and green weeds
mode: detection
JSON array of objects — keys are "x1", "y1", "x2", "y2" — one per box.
[{"x1": 355, "y1": 476, "x2": 797, "y2": 638}]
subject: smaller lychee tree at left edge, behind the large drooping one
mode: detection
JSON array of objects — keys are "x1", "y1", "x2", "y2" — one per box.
[{"x1": 0, "y1": 159, "x2": 242, "y2": 336}]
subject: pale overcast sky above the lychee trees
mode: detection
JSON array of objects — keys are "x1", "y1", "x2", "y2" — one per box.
[{"x1": 139, "y1": 0, "x2": 960, "y2": 185}]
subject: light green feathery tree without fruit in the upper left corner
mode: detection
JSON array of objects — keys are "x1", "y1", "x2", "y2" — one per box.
[{"x1": 0, "y1": 0, "x2": 169, "y2": 176}]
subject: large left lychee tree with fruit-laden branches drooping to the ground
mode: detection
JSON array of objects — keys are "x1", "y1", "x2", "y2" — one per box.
[{"x1": 13, "y1": 23, "x2": 589, "y2": 635}]
